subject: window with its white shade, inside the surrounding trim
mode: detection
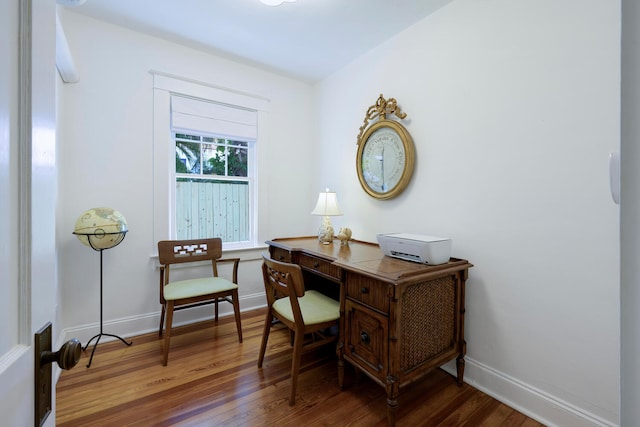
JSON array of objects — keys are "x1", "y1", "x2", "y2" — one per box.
[{"x1": 171, "y1": 94, "x2": 257, "y2": 245}]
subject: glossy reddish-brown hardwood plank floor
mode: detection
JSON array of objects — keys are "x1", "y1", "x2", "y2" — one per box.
[{"x1": 56, "y1": 310, "x2": 542, "y2": 427}]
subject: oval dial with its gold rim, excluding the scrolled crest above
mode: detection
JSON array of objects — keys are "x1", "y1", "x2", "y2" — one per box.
[{"x1": 357, "y1": 120, "x2": 413, "y2": 199}]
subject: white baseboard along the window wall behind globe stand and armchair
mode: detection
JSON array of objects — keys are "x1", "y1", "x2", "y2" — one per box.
[{"x1": 58, "y1": 292, "x2": 266, "y2": 346}]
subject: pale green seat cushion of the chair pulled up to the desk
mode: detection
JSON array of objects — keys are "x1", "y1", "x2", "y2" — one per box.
[{"x1": 273, "y1": 291, "x2": 340, "y2": 325}]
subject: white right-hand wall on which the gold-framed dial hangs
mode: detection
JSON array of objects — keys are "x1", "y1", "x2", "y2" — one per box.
[{"x1": 316, "y1": 0, "x2": 620, "y2": 426}]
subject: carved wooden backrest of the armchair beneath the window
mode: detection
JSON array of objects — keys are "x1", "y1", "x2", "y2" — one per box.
[{"x1": 158, "y1": 237, "x2": 222, "y2": 265}]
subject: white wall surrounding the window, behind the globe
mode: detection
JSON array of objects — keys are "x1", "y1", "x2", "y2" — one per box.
[{"x1": 57, "y1": 10, "x2": 316, "y2": 344}]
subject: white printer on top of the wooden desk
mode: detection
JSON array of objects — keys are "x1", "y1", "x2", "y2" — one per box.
[{"x1": 377, "y1": 233, "x2": 452, "y2": 265}]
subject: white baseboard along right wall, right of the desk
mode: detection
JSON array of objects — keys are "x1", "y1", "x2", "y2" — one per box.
[{"x1": 442, "y1": 357, "x2": 618, "y2": 427}]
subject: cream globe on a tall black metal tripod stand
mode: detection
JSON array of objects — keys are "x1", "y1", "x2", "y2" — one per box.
[{"x1": 73, "y1": 208, "x2": 133, "y2": 368}]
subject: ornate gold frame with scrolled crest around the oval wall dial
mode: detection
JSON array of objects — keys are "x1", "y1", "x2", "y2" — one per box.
[{"x1": 356, "y1": 94, "x2": 415, "y2": 200}]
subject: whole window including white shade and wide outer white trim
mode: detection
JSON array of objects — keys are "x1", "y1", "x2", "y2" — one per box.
[{"x1": 150, "y1": 71, "x2": 269, "y2": 253}]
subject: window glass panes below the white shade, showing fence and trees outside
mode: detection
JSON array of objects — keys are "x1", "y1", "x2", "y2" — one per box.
[{"x1": 174, "y1": 133, "x2": 253, "y2": 243}]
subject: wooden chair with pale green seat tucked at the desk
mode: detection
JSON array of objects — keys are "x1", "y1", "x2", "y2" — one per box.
[{"x1": 258, "y1": 254, "x2": 340, "y2": 405}]
